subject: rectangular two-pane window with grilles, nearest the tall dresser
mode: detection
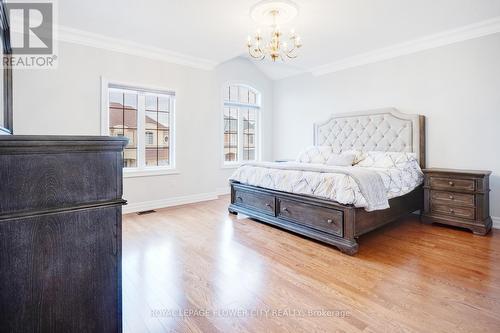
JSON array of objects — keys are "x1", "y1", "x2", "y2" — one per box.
[{"x1": 107, "y1": 84, "x2": 175, "y2": 169}]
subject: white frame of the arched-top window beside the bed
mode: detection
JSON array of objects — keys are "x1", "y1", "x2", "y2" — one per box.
[{"x1": 220, "y1": 81, "x2": 262, "y2": 169}]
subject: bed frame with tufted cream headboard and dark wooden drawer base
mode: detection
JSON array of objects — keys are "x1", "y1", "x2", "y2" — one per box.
[{"x1": 229, "y1": 108, "x2": 425, "y2": 255}]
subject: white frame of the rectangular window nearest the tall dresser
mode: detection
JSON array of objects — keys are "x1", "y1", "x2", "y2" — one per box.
[{"x1": 101, "y1": 77, "x2": 179, "y2": 178}]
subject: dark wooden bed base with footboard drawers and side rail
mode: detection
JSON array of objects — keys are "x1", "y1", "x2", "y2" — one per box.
[{"x1": 229, "y1": 182, "x2": 423, "y2": 255}]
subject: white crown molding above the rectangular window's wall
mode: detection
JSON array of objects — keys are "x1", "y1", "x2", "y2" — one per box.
[{"x1": 56, "y1": 25, "x2": 217, "y2": 70}]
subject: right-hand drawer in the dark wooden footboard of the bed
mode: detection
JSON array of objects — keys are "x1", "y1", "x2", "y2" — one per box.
[{"x1": 278, "y1": 198, "x2": 343, "y2": 237}]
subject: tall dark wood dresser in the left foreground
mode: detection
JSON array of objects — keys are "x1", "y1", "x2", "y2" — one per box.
[{"x1": 0, "y1": 136, "x2": 127, "y2": 333}]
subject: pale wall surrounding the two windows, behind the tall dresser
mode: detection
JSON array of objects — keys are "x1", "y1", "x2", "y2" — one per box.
[{"x1": 14, "y1": 43, "x2": 272, "y2": 210}]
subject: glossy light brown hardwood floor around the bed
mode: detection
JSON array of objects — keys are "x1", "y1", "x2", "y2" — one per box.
[{"x1": 123, "y1": 196, "x2": 500, "y2": 333}]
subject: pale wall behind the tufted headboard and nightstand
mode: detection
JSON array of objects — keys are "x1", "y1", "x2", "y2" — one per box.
[{"x1": 273, "y1": 34, "x2": 500, "y2": 217}]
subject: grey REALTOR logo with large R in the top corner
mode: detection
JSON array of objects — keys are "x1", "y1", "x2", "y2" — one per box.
[{"x1": 4, "y1": 0, "x2": 57, "y2": 68}]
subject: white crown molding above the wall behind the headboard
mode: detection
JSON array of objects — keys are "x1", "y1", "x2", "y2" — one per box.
[{"x1": 310, "y1": 17, "x2": 500, "y2": 76}]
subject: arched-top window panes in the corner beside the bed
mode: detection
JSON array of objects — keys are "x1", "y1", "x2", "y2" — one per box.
[{"x1": 224, "y1": 85, "x2": 260, "y2": 164}]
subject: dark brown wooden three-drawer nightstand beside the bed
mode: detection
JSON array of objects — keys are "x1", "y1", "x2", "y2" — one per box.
[{"x1": 422, "y1": 168, "x2": 491, "y2": 235}]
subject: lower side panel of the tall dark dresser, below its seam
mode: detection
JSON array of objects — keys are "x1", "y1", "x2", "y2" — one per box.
[{"x1": 0, "y1": 205, "x2": 121, "y2": 332}]
